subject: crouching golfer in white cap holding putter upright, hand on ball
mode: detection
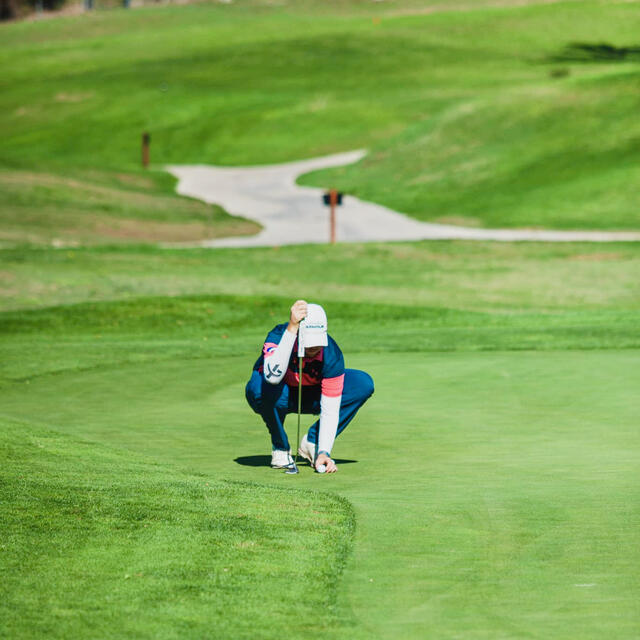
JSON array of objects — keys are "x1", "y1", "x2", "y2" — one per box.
[{"x1": 246, "y1": 300, "x2": 373, "y2": 473}]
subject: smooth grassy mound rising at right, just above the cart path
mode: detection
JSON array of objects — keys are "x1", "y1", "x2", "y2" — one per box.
[{"x1": 301, "y1": 70, "x2": 640, "y2": 229}]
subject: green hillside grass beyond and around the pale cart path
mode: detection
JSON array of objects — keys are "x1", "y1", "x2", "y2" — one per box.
[{"x1": 0, "y1": 1, "x2": 640, "y2": 243}]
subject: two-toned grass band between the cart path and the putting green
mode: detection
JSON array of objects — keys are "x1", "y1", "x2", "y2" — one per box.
[{"x1": 0, "y1": 242, "x2": 640, "y2": 380}]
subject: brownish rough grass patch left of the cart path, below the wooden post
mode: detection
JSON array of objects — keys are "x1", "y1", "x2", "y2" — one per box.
[{"x1": 0, "y1": 171, "x2": 260, "y2": 246}]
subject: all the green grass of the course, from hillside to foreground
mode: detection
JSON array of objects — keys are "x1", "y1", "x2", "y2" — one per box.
[{"x1": 0, "y1": 0, "x2": 640, "y2": 640}]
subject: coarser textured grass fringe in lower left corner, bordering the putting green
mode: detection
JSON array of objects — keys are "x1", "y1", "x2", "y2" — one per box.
[{"x1": 0, "y1": 420, "x2": 354, "y2": 638}]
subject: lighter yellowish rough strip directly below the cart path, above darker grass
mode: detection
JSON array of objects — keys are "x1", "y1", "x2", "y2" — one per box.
[{"x1": 0, "y1": 242, "x2": 640, "y2": 313}]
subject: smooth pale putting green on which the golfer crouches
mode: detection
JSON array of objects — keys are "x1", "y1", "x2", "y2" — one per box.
[{"x1": 2, "y1": 350, "x2": 640, "y2": 638}]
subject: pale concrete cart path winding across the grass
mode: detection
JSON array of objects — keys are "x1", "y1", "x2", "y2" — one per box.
[{"x1": 167, "y1": 151, "x2": 640, "y2": 247}]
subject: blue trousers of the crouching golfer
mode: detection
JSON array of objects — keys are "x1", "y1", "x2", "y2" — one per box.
[{"x1": 245, "y1": 369, "x2": 373, "y2": 451}]
